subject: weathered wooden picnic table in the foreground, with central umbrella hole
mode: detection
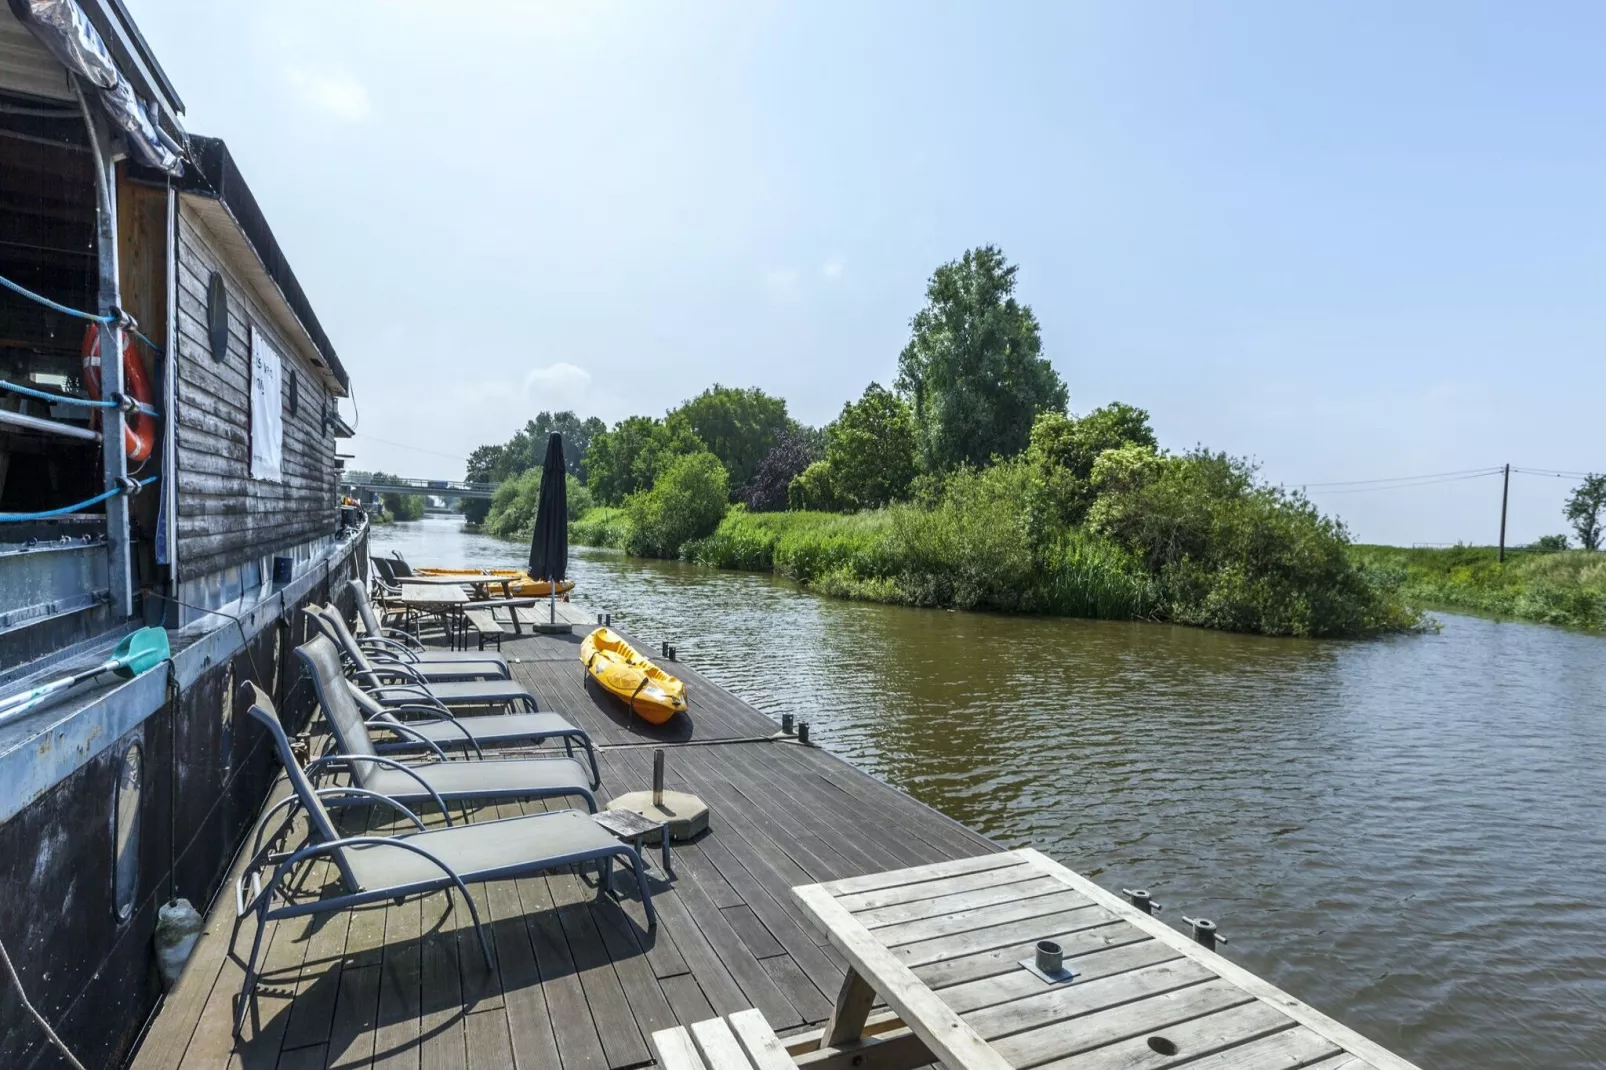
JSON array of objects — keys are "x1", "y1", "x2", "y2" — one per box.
[{"x1": 784, "y1": 848, "x2": 1410, "y2": 1070}]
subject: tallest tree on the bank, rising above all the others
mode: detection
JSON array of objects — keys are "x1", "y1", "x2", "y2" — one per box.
[{"x1": 898, "y1": 246, "x2": 1066, "y2": 471}]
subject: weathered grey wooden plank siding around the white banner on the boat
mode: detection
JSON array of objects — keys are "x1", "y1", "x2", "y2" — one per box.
[{"x1": 173, "y1": 206, "x2": 339, "y2": 580}]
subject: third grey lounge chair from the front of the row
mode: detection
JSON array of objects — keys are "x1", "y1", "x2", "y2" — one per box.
[{"x1": 338, "y1": 661, "x2": 602, "y2": 789}]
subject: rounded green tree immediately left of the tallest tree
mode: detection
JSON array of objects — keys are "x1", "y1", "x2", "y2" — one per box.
[{"x1": 825, "y1": 382, "x2": 917, "y2": 509}]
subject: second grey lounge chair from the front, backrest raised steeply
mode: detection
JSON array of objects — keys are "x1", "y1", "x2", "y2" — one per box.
[{"x1": 296, "y1": 636, "x2": 597, "y2": 813}]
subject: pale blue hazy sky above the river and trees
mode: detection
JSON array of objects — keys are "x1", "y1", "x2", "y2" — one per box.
[{"x1": 128, "y1": 0, "x2": 1606, "y2": 543}]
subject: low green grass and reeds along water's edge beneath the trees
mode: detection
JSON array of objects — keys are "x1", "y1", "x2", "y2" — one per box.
[{"x1": 570, "y1": 485, "x2": 1418, "y2": 635}]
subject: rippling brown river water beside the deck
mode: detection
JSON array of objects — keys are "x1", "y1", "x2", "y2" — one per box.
[{"x1": 374, "y1": 517, "x2": 1606, "y2": 1068}]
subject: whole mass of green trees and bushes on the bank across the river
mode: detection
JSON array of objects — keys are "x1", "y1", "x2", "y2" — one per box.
[{"x1": 469, "y1": 247, "x2": 1418, "y2": 636}]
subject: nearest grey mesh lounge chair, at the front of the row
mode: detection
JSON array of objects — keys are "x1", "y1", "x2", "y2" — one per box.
[{"x1": 234, "y1": 683, "x2": 658, "y2": 1036}]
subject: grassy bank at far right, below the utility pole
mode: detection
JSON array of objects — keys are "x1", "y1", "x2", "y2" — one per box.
[{"x1": 1351, "y1": 546, "x2": 1606, "y2": 630}]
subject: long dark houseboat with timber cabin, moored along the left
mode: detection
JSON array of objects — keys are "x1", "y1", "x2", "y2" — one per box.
[{"x1": 0, "y1": 0, "x2": 366, "y2": 1070}]
